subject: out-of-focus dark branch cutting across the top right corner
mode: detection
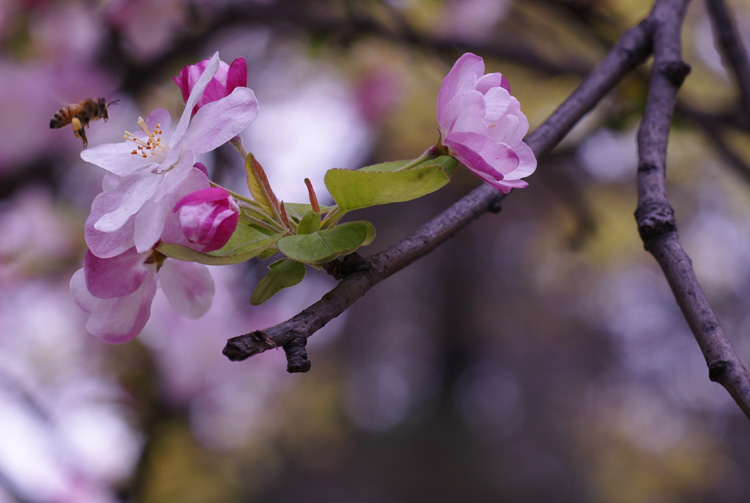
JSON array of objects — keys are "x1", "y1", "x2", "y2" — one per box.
[{"x1": 706, "y1": 0, "x2": 750, "y2": 127}]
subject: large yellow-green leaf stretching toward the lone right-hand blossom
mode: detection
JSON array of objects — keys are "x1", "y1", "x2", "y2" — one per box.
[{"x1": 325, "y1": 155, "x2": 458, "y2": 212}]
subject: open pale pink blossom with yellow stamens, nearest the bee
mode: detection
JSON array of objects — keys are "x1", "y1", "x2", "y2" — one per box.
[{"x1": 81, "y1": 53, "x2": 258, "y2": 257}]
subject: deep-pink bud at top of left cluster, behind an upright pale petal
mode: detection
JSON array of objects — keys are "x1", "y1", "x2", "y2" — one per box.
[{"x1": 173, "y1": 58, "x2": 247, "y2": 114}]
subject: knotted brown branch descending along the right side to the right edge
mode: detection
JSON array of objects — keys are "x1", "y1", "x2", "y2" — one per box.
[{"x1": 636, "y1": 0, "x2": 750, "y2": 418}]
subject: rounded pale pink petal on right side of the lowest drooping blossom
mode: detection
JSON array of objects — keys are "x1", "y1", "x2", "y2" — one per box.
[{"x1": 159, "y1": 259, "x2": 214, "y2": 318}]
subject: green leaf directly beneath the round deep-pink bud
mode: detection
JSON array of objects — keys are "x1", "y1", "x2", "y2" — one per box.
[{"x1": 157, "y1": 225, "x2": 286, "y2": 265}]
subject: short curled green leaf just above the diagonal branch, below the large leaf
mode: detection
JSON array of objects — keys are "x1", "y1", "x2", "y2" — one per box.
[{"x1": 277, "y1": 220, "x2": 375, "y2": 265}]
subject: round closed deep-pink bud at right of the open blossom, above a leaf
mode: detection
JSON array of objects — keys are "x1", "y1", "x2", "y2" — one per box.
[{"x1": 172, "y1": 187, "x2": 240, "y2": 252}]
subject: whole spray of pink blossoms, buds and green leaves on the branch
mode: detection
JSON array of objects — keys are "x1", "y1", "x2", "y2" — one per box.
[{"x1": 70, "y1": 53, "x2": 536, "y2": 343}]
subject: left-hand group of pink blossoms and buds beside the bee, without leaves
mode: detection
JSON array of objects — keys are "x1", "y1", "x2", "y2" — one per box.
[{"x1": 71, "y1": 53, "x2": 258, "y2": 343}]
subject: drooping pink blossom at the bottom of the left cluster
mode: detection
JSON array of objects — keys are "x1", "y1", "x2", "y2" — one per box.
[{"x1": 70, "y1": 248, "x2": 214, "y2": 344}]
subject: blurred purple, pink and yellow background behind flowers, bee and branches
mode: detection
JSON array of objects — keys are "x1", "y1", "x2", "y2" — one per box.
[{"x1": 0, "y1": 0, "x2": 750, "y2": 503}]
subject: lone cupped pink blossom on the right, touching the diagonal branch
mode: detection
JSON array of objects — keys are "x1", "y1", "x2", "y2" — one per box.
[{"x1": 437, "y1": 53, "x2": 536, "y2": 194}]
